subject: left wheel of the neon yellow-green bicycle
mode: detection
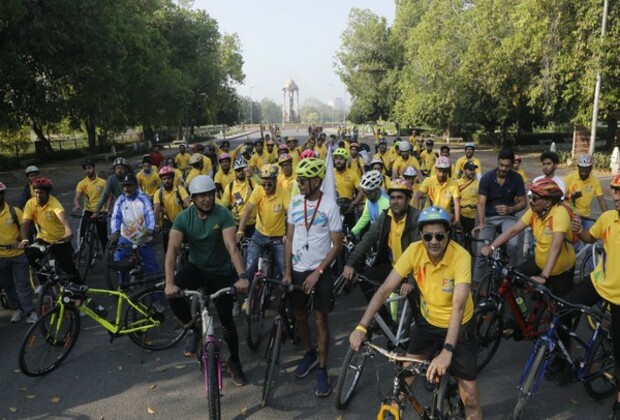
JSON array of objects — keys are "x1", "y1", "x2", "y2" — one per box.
[{"x1": 19, "y1": 305, "x2": 80, "y2": 376}]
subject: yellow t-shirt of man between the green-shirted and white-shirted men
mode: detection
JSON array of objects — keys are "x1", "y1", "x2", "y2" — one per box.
[{"x1": 248, "y1": 187, "x2": 291, "y2": 236}]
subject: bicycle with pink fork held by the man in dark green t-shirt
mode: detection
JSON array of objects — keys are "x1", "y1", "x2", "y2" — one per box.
[{"x1": 180, "y1": 287, "x2": 236, "y2": 419}]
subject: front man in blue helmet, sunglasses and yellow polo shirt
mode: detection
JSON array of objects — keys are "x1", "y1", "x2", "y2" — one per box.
[{"x1": 349, "y1": 206, "x2": 482, "y2": 419}]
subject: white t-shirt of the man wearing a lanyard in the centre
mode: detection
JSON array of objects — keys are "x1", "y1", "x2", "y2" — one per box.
[{"x1": 287, "y1": 194, "x2": 342, "y2": 272}]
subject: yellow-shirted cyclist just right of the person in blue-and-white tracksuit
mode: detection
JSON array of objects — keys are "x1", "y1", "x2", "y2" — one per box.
[{"x1": 153, "y1": 166, "x2": 189, "y2": 254}]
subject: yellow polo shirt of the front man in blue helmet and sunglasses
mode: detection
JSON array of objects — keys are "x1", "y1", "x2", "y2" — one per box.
[{"x1": 394, "y1": 241, "x2": 474, "y2": 328}]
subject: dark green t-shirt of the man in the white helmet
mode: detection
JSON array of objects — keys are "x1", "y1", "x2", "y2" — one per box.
[{"x1": 172, "y1": 204, "x2": 235, "y2": 276}]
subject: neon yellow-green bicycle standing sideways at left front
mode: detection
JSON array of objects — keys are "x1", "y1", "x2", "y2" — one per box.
[{"x1": 19, "y1": 277, "x2": 186, "y2": 376}]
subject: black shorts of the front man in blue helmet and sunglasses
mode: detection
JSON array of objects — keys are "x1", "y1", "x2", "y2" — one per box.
[{"x1": 407, "y1": 317, "x2": 478, "y2": 381}]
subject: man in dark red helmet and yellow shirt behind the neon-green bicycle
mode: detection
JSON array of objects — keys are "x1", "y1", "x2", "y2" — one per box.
[{"x1": 19, "y1": 177, "x2": 82, "y2": 283}]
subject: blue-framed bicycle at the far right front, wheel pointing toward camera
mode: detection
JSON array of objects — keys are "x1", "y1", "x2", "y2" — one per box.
[{"x1": 511, "y1": 278, "x2": 616, "y2": 419}]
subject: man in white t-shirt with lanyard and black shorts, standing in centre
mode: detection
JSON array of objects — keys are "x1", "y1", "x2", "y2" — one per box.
[{"x1": 282, "y1": 158, "x2": 342, "y2": 397}]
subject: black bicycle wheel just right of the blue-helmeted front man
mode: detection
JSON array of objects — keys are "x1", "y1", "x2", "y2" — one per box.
[{"x1": 474, "y1": 304, "x2": 504, "y2": 373}]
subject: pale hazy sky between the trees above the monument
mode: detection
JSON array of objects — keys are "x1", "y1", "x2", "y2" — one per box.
[{"x1": 194, "y1": 0, "x2": 395, "y2": 105}]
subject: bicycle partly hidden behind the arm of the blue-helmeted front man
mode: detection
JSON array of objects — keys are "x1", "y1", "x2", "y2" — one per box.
[{"x1": 335, "y1": 274, "x2": 413, "y2": 410}]
